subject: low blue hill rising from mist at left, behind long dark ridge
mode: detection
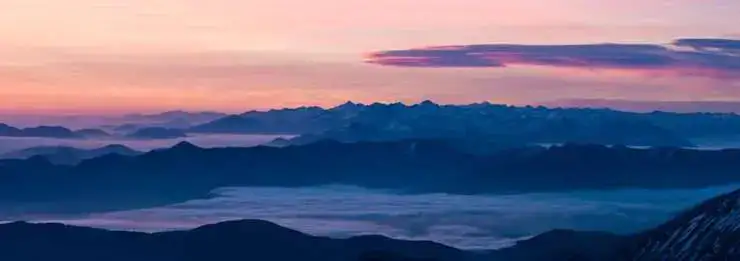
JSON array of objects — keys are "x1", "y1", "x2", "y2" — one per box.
[{"x1": 1, "y1": 145, "x2": 141, "y2": 165}]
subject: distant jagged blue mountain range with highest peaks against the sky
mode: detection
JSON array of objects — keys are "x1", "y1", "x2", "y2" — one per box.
[{"x1": 190, "y1": 101, "x2": 740, "y2": 147}]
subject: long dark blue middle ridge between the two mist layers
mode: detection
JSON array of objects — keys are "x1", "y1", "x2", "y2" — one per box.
[{"x1": 0, "y1": 140, "x2": 740, "y2": 214}]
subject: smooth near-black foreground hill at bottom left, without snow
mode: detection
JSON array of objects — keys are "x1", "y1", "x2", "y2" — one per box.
[{"x1": 0, "y1": 220, "x2": 474, "y2": 261}]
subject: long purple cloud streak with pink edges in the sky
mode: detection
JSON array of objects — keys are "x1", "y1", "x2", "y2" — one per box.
[{"x1": 367, "y1": 39, "x2": 740, "y2": 78}]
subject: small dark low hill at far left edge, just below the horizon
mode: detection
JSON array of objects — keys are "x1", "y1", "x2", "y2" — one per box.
[{"x1": 0, "y1": 123, "x2": 108, "y2": 139}]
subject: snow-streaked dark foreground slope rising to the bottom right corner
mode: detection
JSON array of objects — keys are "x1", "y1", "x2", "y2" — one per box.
[{"x1": 492, "y1": 187, "x2": 740, "y2": 261}]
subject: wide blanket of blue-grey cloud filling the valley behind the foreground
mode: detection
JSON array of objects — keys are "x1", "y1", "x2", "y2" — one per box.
[{"x1": 44, "y1": 186, "x2": 738, "y2": 249}]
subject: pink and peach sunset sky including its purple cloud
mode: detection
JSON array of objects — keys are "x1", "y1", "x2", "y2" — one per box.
[{"x1": 0, "y1": 0, "x2": 740, "y2": 114}]
